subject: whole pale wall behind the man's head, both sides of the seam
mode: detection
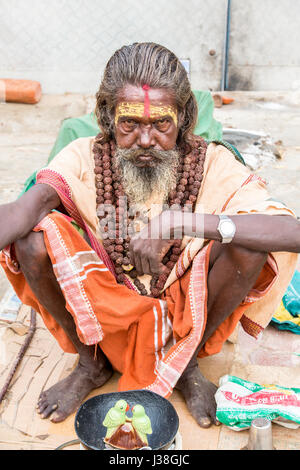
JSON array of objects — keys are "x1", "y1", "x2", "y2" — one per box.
[{"x1": 0, "y1": 0, "x2": 300, "y2": 93}]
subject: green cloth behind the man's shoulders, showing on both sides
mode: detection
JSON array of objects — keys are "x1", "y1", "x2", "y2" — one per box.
[{"x1": 20, "y1": 90, "x2": 222, "y2": 196}]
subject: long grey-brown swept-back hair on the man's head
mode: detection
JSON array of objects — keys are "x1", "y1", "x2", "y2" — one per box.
[{"x1": 95, "y1": 42, "x2": 198, "y2": 151}]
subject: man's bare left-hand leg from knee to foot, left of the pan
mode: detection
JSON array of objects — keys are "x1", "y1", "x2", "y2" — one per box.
[{"x1": 15, "y1": 232, "x2": 112, "y2": 422}]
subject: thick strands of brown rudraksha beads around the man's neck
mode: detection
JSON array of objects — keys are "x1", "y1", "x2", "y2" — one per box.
[{"x1": 93, "y1": 134, "x2": 207, "y2": 297}]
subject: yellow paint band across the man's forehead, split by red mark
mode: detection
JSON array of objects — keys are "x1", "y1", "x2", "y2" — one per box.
[{"x1": 115, "y1": 103, "x2": 178, "y2": 126}]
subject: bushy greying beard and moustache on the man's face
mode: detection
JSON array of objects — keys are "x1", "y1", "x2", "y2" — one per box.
[{"x1": 115, "y1": 148, "x2": 180, "y2": 204}]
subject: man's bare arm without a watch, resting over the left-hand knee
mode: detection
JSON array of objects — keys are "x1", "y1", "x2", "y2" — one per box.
[{"x1": 0, "y1": 184, "x2": 60, "y2": 250}]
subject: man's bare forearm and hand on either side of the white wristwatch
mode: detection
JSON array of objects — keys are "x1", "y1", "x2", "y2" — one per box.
[{"x1": 130, "y1": 211, "x2": 300, "y2": 275}]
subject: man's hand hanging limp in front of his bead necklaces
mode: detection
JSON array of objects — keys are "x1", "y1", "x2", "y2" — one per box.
[{"x1": 129, "y1": 211, "x2": 182, "y2": 276}]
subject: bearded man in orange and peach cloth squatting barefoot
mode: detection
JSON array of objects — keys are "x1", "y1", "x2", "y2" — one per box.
[{"x1": 0, "y1": 43, "x2": 300, "y2": 427}]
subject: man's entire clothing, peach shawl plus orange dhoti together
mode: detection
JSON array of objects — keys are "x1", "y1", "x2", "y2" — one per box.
[{"x1": 0, "y1": 138, "x2": 297, "y2": 397}]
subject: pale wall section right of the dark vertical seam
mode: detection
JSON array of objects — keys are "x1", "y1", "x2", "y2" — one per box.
[{"x1": 228, "y1": 0, "x2": 300, "y2": 90}]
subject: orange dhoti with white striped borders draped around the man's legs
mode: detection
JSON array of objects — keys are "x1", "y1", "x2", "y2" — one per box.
[{"x1": 0, "y1": 212, "x2": 288, "y2": 397}]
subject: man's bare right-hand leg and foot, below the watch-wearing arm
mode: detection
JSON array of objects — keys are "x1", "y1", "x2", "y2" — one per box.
[{"x1": 176, "y1": 242, "x2": 268, "y2": 427}]
